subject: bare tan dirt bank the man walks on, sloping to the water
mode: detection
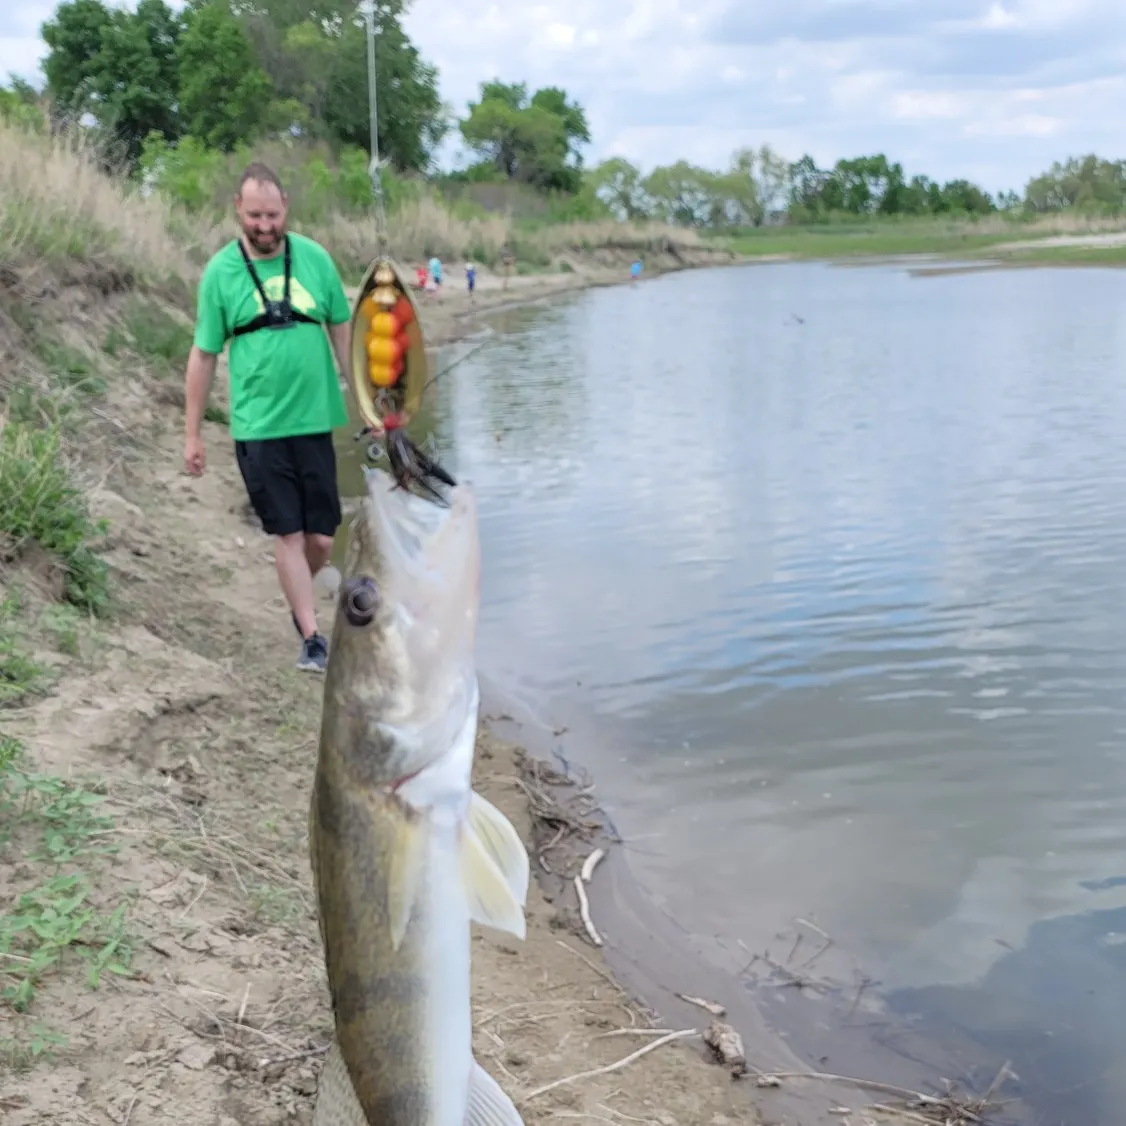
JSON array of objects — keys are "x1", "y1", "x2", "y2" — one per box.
[{"x1": 0, "y1": 255, "x2": 756, "y2": 1126}]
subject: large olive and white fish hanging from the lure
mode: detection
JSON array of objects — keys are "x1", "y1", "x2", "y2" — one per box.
[{"x1": 309, "y1": 466, "x2": 530, "y2": 1126}]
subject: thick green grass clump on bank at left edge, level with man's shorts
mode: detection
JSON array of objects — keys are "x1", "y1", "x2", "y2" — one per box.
[{"x1": 0, "y1": 419, "x2": 109, "y2": 614}]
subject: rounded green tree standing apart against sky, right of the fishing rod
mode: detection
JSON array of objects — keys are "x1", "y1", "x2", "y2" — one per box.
[{"x1": 459, "y1": 81, "x2": 590, "y2": 194}]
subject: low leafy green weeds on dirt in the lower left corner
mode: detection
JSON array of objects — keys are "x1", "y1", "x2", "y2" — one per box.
[{"x1": 0, "y1": 735, "x2": 133, "y2": 1017}]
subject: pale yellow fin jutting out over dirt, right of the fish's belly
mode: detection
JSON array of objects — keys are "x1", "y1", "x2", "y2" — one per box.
[{"x1": 462, "y1": 794, "x2": 528, "y2": 938}]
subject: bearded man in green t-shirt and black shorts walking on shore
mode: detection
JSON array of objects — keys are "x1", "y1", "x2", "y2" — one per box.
[{"x1": 184, "y1": 162, "x2": 351, "y2": 672}]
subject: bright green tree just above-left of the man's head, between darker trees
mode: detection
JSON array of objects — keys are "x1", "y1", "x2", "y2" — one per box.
[{"x1": 177, "y1": 0, "x2": 274, "y2": 152}]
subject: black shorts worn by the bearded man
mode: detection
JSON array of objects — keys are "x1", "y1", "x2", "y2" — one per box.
[{"x1": 234, "y1": 432, "x2": 340, "y2": 536}]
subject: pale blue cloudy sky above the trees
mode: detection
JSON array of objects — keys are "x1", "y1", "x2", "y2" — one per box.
[{"x1": 0, "y1": 0, "x2": 1126, "y2": 191}]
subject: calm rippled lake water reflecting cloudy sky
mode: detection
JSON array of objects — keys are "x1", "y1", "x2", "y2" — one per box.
[{"x1": 337, "y1": 263, "x2": 1126, "y2": 1126}]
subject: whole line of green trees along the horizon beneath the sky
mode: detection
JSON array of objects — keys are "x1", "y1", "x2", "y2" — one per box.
[{"x1": 0, "y1": 0, "x2": 1126, "y2": 231}]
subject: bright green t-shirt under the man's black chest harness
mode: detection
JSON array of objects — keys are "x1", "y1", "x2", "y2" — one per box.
[{"x1": 195, "y1": 233, "x2": 351, "y2": 441}]
